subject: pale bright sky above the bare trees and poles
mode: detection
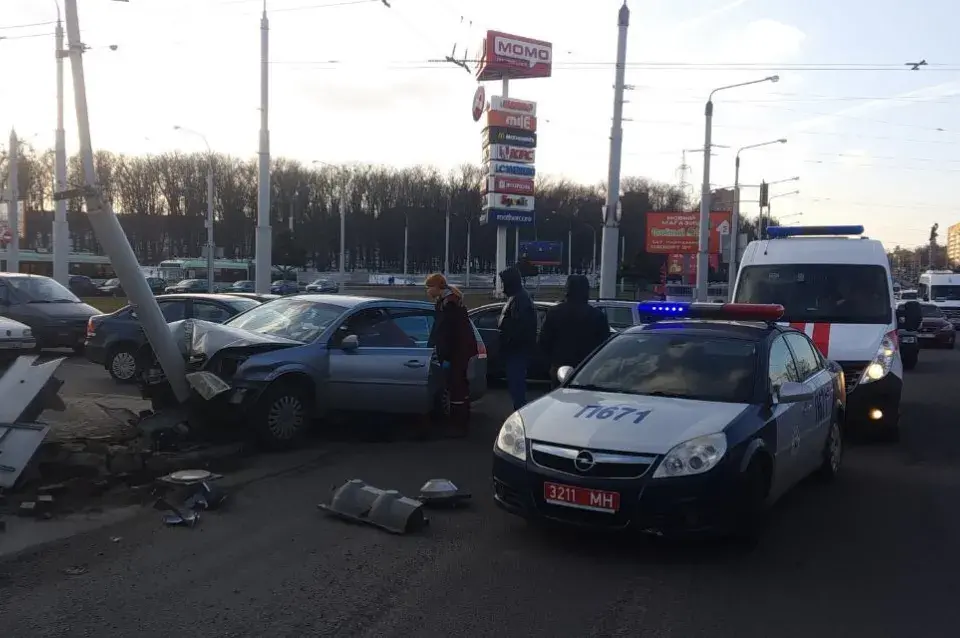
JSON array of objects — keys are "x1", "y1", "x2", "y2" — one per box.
[{"x1": 0, "y1": 0, "x2": 960, "y2": 247}]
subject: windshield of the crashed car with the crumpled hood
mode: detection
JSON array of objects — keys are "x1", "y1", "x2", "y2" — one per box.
[{"x1": 226, "y1": 299, "x2": 344, "y2": 343}]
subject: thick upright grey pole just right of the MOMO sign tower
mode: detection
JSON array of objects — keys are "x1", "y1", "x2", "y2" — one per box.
[{"x1": 599, "y1": 0, "x2": 630, "y2": 299}]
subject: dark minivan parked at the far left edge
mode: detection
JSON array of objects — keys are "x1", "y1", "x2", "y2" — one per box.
[{"x1": 0, "y1": 273, "x2": 100, "y2": 353}]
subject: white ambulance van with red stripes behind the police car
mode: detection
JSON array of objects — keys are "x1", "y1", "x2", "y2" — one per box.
[{"x1": 734, "y1": 226, "x2": 903, "y2": 440}]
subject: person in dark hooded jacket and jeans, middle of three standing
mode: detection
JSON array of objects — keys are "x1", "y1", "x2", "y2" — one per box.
[{"x1": 497, "y1": 268, "x2": 537, "y2": 410}]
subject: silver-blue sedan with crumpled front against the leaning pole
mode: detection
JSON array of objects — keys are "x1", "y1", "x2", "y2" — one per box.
[{"x1": 135, "y1": 295, "x2": 487, "y2": 447}]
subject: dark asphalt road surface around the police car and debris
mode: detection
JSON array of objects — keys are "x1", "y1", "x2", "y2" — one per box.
[{"x1": 0, "y1": 351, "x2": 960, "y2": 638}]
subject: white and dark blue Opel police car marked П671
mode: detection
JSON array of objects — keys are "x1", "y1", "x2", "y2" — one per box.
[{"x1": 493, "y1": 302, "x2": 844, "y2": 535}]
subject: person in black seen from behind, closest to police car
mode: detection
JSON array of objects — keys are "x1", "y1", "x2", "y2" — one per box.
[{"x1": 540, "y1": 275, "x2": 610, "y2": 385}]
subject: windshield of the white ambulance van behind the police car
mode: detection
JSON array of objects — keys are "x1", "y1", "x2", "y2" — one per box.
[{"x1": 736, "y1": 264, "x2": 892, "y2": 324}]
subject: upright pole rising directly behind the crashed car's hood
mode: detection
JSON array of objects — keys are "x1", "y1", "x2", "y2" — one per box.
[{"x1": 255, "y1": 0, "x2": 272, "y2": 295}]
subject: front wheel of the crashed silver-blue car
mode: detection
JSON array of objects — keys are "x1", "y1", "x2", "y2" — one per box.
[{"x1": 253, "y1": 378, "x2": 313, "y2": 449}]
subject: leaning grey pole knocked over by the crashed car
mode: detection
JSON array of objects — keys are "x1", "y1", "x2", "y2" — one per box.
[{"x1": 58, "y1": 0, "x2": 190, "y2": 403}]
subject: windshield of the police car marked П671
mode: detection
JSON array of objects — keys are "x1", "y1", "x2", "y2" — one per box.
[{"x1": 567, "y1": 332, "x2": 757, "y2": 403}]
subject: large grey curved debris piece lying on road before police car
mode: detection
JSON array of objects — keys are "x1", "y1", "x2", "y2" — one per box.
[{"x1": 317, "y1": 479, "x2": 430, "y2": 534}]
